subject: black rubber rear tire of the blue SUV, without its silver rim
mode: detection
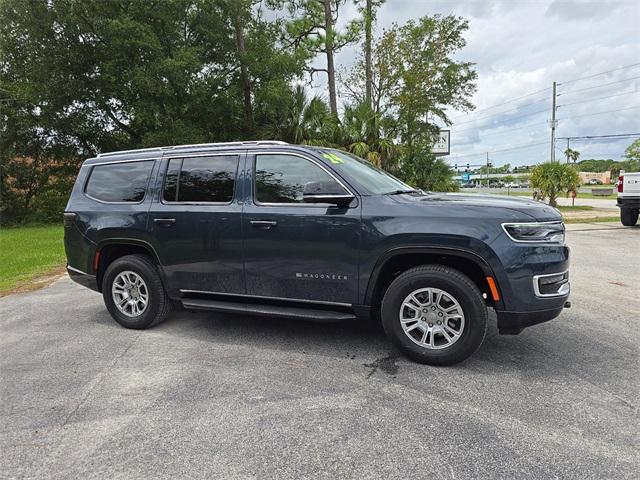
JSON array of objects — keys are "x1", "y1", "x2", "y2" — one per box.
[{"x1": 102, "y1": 255, "x2": 171, "y2": 330}]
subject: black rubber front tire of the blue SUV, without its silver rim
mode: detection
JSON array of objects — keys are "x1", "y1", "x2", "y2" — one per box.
[{"x1": 381, "y1": 265, "x2": 487, "y2": 365}]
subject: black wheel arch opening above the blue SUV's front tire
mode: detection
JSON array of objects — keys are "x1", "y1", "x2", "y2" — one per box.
[{"x1": 364, "y1": 246, "x2": 503, "y2": 307}]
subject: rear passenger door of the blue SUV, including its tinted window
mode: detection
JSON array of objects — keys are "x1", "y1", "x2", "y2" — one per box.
[{"x1": 149, "y1": 151, "x2": 245, "y2": 294}]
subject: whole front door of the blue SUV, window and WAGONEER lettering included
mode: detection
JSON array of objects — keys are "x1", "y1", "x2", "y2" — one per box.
[{"x1": 242, "y1": 152, "x2": 360, "y2": 304}]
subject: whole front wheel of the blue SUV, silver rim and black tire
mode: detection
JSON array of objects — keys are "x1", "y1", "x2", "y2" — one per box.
[{"x1": 382, "y1": 265, "x2": 487, "y2": 365}]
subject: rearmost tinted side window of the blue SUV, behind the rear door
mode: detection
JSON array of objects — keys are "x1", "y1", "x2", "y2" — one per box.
[{"x1": 85, "y1": 160, "x2": 153, "y2": 202}]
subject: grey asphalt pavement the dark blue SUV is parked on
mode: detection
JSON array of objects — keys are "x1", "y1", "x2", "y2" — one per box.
[{"x1": 0, "y1": 225, "x2": 640, "y2": 479}]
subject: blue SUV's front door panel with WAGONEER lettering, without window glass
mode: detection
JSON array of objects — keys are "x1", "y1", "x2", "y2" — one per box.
[{"x1": 242, "y1": 150, "x2": 361, "y2": 304}]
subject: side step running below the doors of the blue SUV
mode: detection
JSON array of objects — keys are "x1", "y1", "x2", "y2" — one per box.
[{"x1": 182, "y1": 298, "x2": 356, "y2": 322}]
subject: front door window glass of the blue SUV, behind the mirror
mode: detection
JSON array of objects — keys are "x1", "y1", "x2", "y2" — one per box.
[{"x1": 255, "y1": 154, "x2": 344, "y2": 203}]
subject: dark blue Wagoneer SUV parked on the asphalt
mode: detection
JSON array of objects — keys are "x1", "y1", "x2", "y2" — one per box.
[{"x1": 64, "y1": 141, "x2": 569, "y2": 365}]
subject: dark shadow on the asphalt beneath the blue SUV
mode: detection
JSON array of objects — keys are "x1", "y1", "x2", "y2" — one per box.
[{"x1": 85, "y1": 309, "x2": 610, "y2": 377}]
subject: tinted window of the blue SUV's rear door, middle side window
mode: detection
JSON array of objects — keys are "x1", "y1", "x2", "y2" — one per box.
[{"x1": 162, "y1": 155, "x2": 239, "y2": 203}]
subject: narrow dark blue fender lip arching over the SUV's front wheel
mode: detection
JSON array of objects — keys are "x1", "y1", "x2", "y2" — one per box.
[{"x1": 364, "y1": 245, "x2": 502, "y2": 307}]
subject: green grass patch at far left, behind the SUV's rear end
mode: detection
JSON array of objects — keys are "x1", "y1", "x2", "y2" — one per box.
[{"x1": 0, "y1": 225, "x2": 65, "y2": 292}]
